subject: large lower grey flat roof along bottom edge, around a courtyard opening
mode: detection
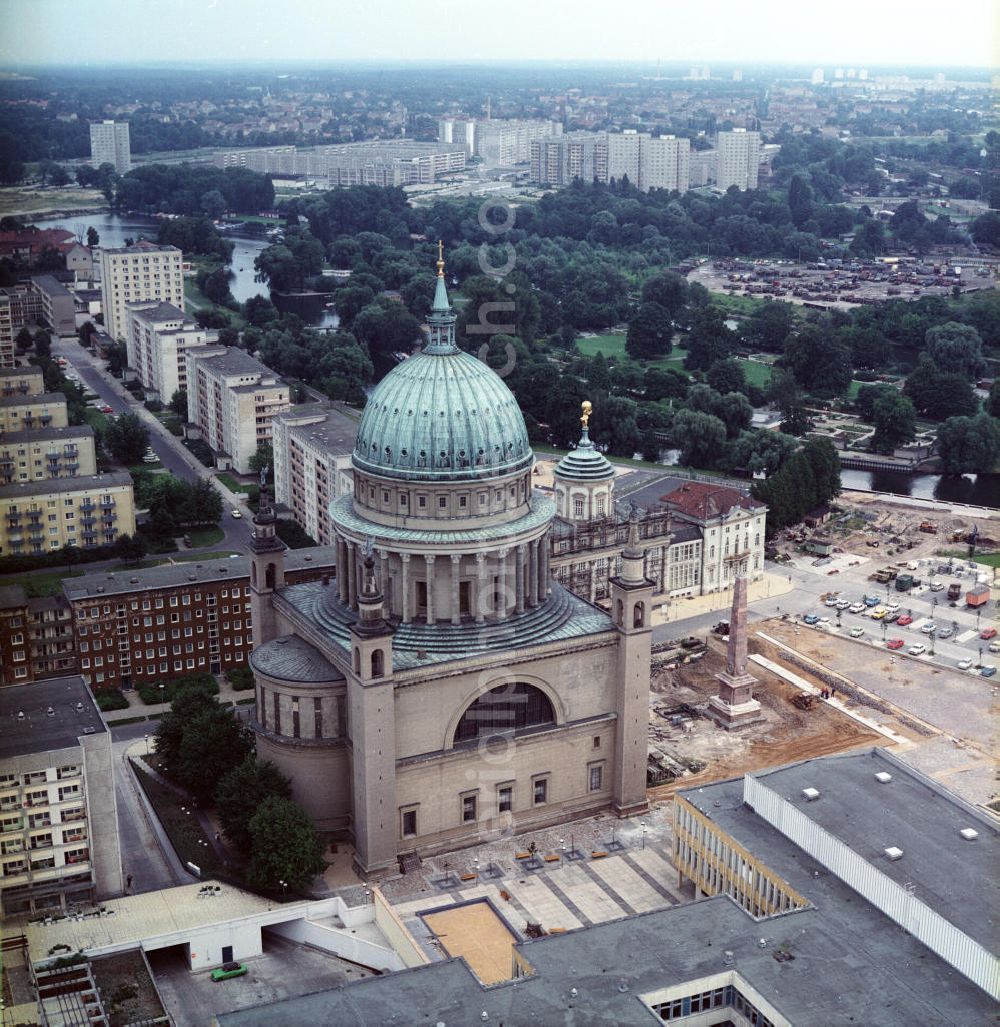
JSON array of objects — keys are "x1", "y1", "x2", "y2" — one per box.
[{"x1": 216, "y1": 891, "x2": 995, "y2": 1027}]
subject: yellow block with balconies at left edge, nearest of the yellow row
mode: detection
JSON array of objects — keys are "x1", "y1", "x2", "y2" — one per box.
[{"x1": 0, "y1": 472, "x2": 136, "y2": 556}]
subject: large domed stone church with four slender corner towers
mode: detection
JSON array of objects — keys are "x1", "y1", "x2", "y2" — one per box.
[{"x1": 251, "y1": 252, "x2": 652, "y2": 874}]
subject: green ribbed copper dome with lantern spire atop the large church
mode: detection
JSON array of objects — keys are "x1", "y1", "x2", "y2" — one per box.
[{"x1": 353, "y1": 276, "x2": 534, "y2": 481}]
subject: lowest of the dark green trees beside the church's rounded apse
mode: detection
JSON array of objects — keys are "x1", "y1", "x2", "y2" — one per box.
[{"x1": 247, "y1": 796, "x2": 325, "y2": 891}]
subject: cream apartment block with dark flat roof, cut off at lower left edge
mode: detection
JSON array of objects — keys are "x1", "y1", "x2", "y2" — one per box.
[{"x1": 0, "y1": 677, "x2": 123, "y2": 916}]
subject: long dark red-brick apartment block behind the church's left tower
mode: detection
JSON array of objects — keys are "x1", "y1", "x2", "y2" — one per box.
[{"x1": 63, "y1": 546, "x2": 336, "y2": 689}]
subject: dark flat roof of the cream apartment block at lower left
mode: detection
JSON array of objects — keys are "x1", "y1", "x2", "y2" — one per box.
[{"x1": 0, "y1": 675, "x2": 107, "y2": 759}]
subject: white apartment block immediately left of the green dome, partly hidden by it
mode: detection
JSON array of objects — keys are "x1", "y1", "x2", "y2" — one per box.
[{"x1": 272, "y1": 404, "x2": 357, "y2": 545}]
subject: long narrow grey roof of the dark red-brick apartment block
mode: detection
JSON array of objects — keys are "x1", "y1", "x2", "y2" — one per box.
[{"x1": 63, "y1": 545, "x2": 337, "y2": 601}]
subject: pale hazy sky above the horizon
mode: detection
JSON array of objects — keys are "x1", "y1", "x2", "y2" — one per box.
[{"x1": 0, "y1": 0, "x2": 1000, "y2": 68}]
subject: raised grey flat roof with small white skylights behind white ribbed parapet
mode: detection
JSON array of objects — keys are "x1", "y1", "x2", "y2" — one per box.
[{"x1": 698, "y1": 749, "x2": 1000, "y2": 949}]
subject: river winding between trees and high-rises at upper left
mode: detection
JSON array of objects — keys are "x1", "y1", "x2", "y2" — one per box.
[{"x1": 35, "y1": 213, "x2": 339, "y2": 328}]
